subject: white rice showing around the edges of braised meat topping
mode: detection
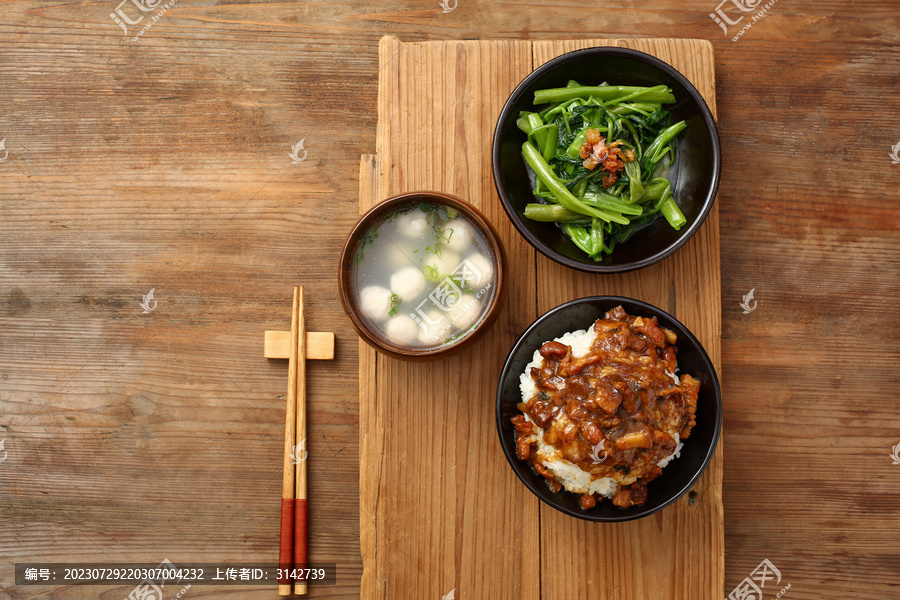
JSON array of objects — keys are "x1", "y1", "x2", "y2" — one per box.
[{"x1": 519, "y1": 327, "x2": 684, "y2": 498}]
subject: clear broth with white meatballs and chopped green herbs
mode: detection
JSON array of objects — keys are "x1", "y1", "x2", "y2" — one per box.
[{"x1": 352, "y1": 203, "x2": 496, "y2": 350}]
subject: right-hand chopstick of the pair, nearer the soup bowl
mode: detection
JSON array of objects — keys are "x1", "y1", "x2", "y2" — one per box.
[{"x1": 294, "y1": 286, "x2": 309, "y2": 596}]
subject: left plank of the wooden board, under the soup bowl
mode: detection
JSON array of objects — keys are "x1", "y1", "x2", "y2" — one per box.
[{"x1": 360, "y1": 37, "x2": 540, "y2": 600}]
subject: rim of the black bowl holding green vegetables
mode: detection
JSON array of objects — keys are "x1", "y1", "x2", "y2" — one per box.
[{"x1": 491, "y1": 46, "x2": 722, "y2": 273}]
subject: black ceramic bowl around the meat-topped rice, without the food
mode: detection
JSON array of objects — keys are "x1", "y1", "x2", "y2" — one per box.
[{"x1": 496, "y1": 296, "x2": 722, "y2": 522}]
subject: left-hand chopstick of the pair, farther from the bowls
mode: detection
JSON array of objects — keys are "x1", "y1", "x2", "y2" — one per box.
[{"x1": 278, "y1": 287, "x2": 306, "y2": 596}]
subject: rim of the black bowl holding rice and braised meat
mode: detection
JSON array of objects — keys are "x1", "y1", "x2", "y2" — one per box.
[{"x1": 494, "y1": 296, "x2": 723, "y2": 523}]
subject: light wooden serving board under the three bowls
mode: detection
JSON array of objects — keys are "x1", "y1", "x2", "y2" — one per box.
[{"x1": 359, "y1": 37, "x2": 724, "y2": 600}]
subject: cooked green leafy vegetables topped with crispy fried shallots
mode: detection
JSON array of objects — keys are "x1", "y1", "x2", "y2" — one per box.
[{"x1": 512, "y1": 81, "x2": 687, "y2": 261}]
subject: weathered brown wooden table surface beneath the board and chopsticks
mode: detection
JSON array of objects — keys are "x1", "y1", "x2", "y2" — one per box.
[{"x1": 0, "y1": 0, "x2": 900, "y2": 600}]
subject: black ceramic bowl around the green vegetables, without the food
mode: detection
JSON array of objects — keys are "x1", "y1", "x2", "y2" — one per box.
[{"x1": 491, "y1": 48, "x2": 721, "y2": 273}]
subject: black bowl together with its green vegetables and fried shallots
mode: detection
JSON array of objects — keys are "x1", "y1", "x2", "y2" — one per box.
[{"x1": 492, "y1": 47, "x2": 721, "y2": 273}]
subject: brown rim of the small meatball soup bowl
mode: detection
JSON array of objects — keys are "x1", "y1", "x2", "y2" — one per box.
[{"x1": 338, "y1": 190, "x2": 507, "y2": 361}]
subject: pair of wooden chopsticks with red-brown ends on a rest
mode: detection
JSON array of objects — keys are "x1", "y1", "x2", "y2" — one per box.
[{"x1": 278, "y1": 286, "x2": 309, "y2": 596}]
